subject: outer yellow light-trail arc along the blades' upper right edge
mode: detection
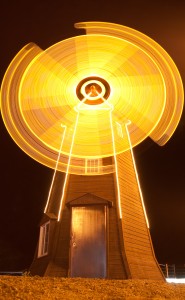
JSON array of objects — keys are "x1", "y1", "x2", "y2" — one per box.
[{"x1": 75, "y1": 22, "x2": 184, "y2": 146}]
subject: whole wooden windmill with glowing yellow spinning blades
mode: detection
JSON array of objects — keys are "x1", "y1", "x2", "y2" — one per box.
[{"x1": 1, "y1": 22, "x2": 183, "y2": 280}]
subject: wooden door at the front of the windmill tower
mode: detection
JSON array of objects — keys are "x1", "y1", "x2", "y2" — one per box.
[{"x1": 70, "y1": 205, "x2": 107, "y2": 278}]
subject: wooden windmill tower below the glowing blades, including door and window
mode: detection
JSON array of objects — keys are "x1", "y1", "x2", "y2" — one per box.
[{"x1": 30, "y1": 151, "x2": 164, "y2": 280}]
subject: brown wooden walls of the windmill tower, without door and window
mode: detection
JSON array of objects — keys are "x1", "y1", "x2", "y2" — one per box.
[{"x1": 30, "y1": 151, "x2": 163, "y2": 280}]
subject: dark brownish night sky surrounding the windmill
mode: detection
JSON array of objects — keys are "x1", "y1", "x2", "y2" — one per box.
[{"x1": 0, "y1": 0, "x2": 185, "y2": 271}]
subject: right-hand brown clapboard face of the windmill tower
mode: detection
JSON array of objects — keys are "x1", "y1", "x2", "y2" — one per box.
[{"x1": 117, "y1": 151, "x2": 164, "y2": 280}]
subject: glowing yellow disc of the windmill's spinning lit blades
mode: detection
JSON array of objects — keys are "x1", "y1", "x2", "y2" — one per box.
[{"x1": 1, "y1": 22, "x2": 183, "y2": 176}]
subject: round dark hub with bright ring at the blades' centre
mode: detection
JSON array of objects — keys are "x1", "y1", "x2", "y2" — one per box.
[{"x1": 76, "y1": 76, "x2": 110, "y2": 105}]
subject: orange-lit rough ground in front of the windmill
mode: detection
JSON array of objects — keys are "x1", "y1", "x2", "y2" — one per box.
[{"x1": 0, "y1": 276, "x2": 185, "y2": 300}]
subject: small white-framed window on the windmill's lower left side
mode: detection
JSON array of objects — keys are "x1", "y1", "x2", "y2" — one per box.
[{"x1": 38, "y1": 222, "x2": 49, "y2": 257}]
